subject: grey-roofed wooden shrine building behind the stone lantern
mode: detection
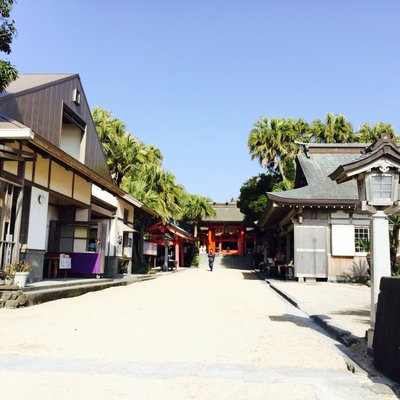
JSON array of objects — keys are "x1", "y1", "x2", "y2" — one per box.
[{"x1": 258, "y1": 144, "x2": 369, "y2": 280}]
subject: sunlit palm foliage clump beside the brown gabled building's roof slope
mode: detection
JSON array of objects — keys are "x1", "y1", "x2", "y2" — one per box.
[{"x1": 93, "y1": 107, "x2": 216, "y2": 222}]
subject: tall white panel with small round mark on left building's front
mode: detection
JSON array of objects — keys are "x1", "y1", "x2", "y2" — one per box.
[{"x1": 27, "y1": 187, "x2": 49, "y2": 250}]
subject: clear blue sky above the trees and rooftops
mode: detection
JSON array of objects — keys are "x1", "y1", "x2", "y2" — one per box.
[{"x1": 9, "y1": 0, "x2": 400, "y2": 202}]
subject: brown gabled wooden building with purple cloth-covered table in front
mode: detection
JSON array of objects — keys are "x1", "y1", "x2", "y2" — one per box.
[{"x1": 0, "y1": 74, "x2": 157, "y2": 281}]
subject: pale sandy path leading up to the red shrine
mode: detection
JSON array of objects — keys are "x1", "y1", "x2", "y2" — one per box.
[{"x1": 0, "y1": 268, "x2": 395, "y2": 400}]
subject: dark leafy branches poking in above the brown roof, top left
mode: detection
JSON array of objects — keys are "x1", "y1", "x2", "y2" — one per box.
[{"x1": 0, "y1": 0, "x2": 18, "y2": 92}]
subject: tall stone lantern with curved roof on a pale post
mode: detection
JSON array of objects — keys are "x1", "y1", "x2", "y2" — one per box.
[{"x1": 329, "y1": 133, "x2": 400, "y2": 347}]
